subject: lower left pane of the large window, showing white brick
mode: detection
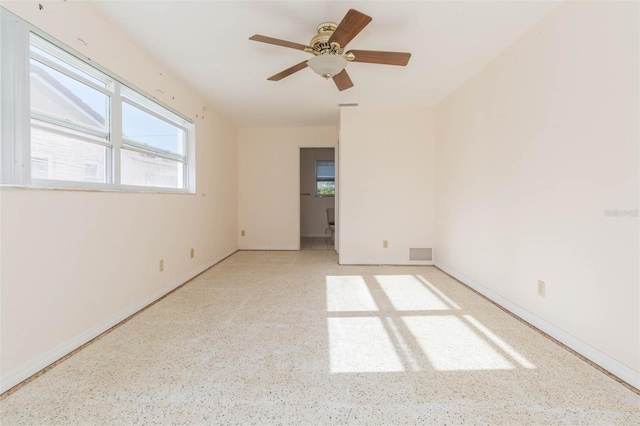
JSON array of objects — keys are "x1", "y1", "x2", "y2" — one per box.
[{"x1": 31, "y1": 125, "x2": 107, "y2": 183}]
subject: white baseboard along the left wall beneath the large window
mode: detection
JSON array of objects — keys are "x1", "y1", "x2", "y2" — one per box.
[{"x1": 0, "y1": 249, "x2": 237, "y2": 393}]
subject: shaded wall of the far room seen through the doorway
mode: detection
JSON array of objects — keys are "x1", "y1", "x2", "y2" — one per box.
[{"x1": 300, "y1": 148, "x2": 335, "y2": 237}]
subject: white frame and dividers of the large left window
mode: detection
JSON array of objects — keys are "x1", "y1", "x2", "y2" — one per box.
[{"x1": 0, "y1": 7, "x2": 196, "y2": 194}]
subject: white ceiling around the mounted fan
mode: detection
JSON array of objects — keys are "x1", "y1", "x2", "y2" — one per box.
[{"x1": 91, "y1": 1, "x2": 558, "y2": 127}]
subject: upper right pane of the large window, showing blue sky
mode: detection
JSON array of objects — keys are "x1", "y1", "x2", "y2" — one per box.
[{"x1": 122, "y1": 102, "x2": 185, "y2": 156}]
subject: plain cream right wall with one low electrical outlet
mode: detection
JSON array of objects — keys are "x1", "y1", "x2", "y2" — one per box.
[{"x1": 436, "y1": 2, "x2": 640, "y2": 386}]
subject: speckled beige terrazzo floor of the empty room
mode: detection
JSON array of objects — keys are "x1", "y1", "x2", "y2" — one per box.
[{"x1": 0, "y1": 250, "x2": 640, "y2": 425}]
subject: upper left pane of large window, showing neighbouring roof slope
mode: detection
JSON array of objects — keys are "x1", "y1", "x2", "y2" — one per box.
[{"x1": 30, "y1": 59, "x2": 109, "y2": 130}]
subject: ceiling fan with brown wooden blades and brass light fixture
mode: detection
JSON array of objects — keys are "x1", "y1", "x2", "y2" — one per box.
[{"x1": 249, "y1": 9, "x2": 411, "y2": 91}]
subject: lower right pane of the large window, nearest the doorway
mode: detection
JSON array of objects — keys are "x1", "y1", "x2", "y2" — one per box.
[{"x1": 121, "y1": 149, "x2": 184, "y2": 188}]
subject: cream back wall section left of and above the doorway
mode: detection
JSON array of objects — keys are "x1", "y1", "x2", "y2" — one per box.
[{"x1": 238, "y1": 127, "x2": 338, "y2": 250}]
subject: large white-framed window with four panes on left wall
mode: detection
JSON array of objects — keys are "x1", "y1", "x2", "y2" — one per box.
[{"x1": 0, "y1": 10, "x2": 195, "y2": 192}]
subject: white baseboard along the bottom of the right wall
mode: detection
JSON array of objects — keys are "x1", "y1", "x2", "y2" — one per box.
[{"x1": 435, "y1": 261, "x2": 640, "y2": 389}]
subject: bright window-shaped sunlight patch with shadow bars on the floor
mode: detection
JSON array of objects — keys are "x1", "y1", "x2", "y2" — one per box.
[{"x1": 326, "y1": 275, "x2": 535, "y2": 373}]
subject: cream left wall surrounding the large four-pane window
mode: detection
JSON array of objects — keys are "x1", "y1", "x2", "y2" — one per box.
[{"x1": 0, "y1": 1, "x2": 238, "y2": 390}]
